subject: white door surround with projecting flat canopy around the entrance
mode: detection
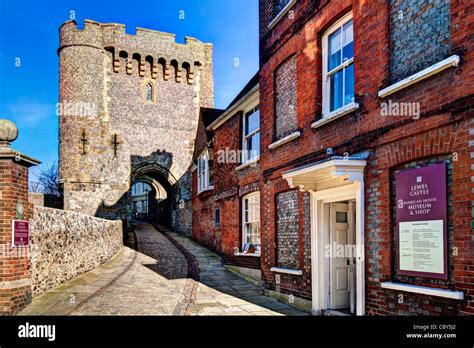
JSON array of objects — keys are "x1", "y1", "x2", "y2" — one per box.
[{"x1": 283, "y1": 159, "x2": 366, "y2": 315}]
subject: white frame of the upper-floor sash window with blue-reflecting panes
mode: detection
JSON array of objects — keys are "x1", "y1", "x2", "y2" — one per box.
[{"x1": 322, "y1": 12, "x2": 356, "y2": 117}]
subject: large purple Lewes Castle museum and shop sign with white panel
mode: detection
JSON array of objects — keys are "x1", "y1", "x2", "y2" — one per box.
[{"x1": 395, "y1": 163, "x2": 448, "y2": 279}]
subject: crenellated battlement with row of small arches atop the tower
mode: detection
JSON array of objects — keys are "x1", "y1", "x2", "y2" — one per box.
[{"x1": 58, "y1": 19, "x2": 212, "y2": 84}]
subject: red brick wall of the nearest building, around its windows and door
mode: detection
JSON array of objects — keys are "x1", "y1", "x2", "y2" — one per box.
[{"x1": 260, "y1": 0, "x2": 474, "y2": 315}]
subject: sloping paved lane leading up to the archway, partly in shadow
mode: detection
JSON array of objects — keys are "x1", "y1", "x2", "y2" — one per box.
[{"x1": 20, "y1": 224, "x2": 306, "y2": 315}]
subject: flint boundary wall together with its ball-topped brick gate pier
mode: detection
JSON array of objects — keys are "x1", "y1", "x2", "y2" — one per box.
[{"x1": 0, "y1": 120, "x2": 123, "y2": 315}]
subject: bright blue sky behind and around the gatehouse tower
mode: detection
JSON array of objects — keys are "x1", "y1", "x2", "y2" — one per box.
[{"x1": 0, "y1": 0, "x2": 258, "y2": 178}]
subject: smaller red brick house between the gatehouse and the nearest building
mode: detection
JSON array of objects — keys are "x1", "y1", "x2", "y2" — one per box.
[{"x1": 193, "y1": 74, "x2": 260, "y2": 279}]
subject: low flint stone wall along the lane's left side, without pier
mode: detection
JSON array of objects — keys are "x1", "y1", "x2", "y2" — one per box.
[{"x1": 30, "y1": 206, "x2": 123, "y2": 296}]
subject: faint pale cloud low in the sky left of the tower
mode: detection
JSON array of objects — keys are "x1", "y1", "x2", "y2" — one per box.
[{"x1": 8, "y1": 98, "x2": 56, "y2": 127}]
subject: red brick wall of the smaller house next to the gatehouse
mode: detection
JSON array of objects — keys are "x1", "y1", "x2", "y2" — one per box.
[{"x1": 193, "y1": 98, "x2": 260, "y2": 269}]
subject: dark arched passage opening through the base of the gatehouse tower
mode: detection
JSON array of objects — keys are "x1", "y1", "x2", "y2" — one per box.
[{"x1": 127, "y1": 164, "x2": 176, "y2": 226}]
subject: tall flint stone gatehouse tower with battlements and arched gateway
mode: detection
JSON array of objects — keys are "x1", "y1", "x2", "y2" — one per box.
[{"x1": 58, "y1": 20, "x2": 214, "y2": 232}]
